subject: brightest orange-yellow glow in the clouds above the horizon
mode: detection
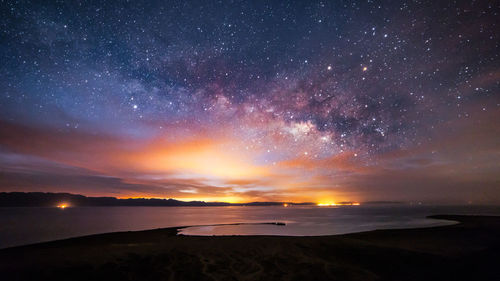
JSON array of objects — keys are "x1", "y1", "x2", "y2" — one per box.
[{"x1": 29, "y1": 123, "x2": 366, "y2": 203}]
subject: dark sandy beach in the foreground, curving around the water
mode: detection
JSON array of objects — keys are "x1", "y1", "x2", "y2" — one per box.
[{"x1": 0, "y1": 216, "x2": 500, "y2": 281}]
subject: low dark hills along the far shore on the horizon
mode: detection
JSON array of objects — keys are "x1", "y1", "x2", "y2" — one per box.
[{"x1": 0, "y1": 192, "x2": 313, "y2": 207}]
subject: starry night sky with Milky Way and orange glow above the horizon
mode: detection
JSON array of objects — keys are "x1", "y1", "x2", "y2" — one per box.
[{"x1": 0, "y1": 1, "x2": 500, "y2": 201}]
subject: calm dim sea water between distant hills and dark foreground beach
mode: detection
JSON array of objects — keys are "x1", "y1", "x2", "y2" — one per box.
[{"x1": 0, "y1": 204, "x2": 500, "y2": 248}]
